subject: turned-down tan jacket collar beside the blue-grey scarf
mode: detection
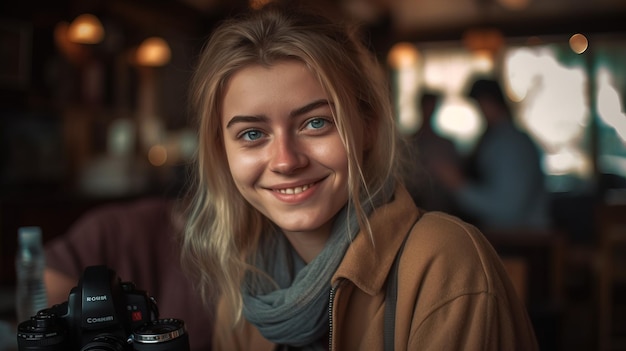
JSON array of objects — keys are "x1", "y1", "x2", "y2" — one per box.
[{"x1": 331, "y1": 185, "x2": 421, "y2": 295}]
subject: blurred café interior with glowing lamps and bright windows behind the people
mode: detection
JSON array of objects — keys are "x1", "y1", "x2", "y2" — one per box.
[{"x1": 0, "y1": 0, "x2": 626, "y2": 350}]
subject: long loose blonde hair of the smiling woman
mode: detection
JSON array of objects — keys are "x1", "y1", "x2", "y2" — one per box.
[{"x1": 182, "y1": 2, "x2": 398, "y2": 319}]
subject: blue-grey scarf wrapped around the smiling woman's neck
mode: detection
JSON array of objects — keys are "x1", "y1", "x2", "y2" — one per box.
[{"x1": 242, "y1": 182, "x2": 393, "y2": 350}]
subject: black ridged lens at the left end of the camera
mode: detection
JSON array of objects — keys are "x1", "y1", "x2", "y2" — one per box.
[{"x1": 17, "y1": 309, "x2": 67, "y2": 351}]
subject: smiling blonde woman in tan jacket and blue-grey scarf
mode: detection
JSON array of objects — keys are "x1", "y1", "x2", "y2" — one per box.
[{"x1": 183, "y1": 6, "x2": 536, "y2": 350}]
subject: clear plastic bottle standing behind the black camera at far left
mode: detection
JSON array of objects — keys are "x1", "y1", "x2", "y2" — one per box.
[{"x1": 15, "y1": 227, "x2": 48, "y2": 322}]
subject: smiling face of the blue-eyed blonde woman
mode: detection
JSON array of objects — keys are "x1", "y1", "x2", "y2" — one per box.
[{"x1": 221, "y1": 61, "x2": 348, "y2": 240}]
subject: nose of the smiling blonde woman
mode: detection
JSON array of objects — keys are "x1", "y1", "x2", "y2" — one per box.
[{"x1": 269, "y1": 135, "x2": 308, "y2": 174}]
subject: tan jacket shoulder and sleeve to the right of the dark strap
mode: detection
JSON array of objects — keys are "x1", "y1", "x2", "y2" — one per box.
[{"x1": 397, "y1": 212, "x2": 536, "y2": 350}]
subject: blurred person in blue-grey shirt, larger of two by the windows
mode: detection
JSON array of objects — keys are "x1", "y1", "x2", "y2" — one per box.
[{"x1": 436, "y1": 78, "x2": 550, "y2": 230}]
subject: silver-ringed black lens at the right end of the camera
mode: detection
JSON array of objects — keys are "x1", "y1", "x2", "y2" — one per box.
[{"x1": 133, "y1": 318, "x2": 189, "y2": 351}]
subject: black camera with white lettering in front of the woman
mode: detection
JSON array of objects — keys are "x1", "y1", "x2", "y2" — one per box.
[{"x1": 17, "y1": 265, "x2": 189, "y2": 351}]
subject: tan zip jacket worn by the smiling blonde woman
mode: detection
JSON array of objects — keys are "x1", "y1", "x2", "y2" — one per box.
[{"x1": 214, "y1": 188, "x2": 538, "y2": 351}]
